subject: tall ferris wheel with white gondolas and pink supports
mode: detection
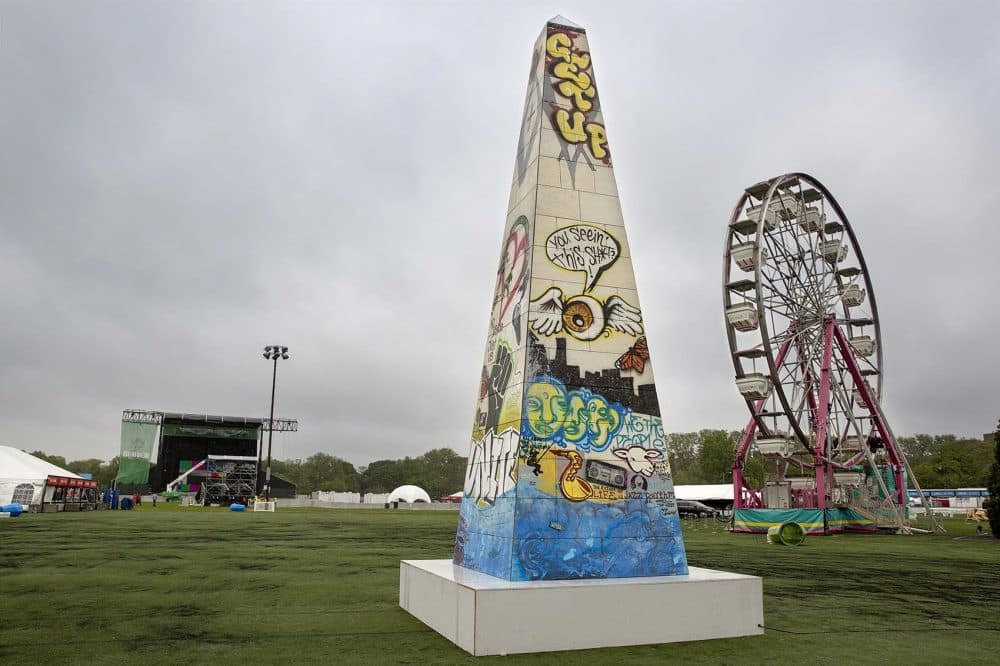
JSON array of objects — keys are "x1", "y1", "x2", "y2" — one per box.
[{"x1": 723, "y1": 173, "x2": 929, "y2": 526}]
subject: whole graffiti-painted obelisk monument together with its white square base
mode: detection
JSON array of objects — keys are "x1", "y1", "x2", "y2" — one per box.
[{"x1": 399, "y1": 16, "x2": 764, "y2": 655}]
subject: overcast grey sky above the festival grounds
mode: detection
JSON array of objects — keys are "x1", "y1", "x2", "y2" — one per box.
[{"x1": 0, "y1": 0, "x2": 1000, "y2": 464}]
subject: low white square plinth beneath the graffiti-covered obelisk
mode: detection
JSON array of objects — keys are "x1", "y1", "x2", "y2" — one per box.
[{"x1": 399, "y1": 560, "x2": 764, "y2": 656}]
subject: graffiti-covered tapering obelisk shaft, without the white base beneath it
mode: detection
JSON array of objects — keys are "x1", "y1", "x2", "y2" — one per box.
[{"x1": 454, "y1": 17, "x2": 688, "y2": 580}]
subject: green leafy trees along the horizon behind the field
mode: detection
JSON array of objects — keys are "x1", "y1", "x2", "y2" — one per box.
[{"x1": 31, "y1": 429, "x2": 996, "y2": 499}]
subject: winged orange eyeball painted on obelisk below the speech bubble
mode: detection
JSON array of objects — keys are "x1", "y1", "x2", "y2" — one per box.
[{"x1": 528, "y1": 287, "x2": 642, "y2": 341}]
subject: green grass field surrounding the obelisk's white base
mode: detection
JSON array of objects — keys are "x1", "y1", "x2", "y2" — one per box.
[{"x1": 0, "y1": 504, "x2": 1000, "y2": 665}]
